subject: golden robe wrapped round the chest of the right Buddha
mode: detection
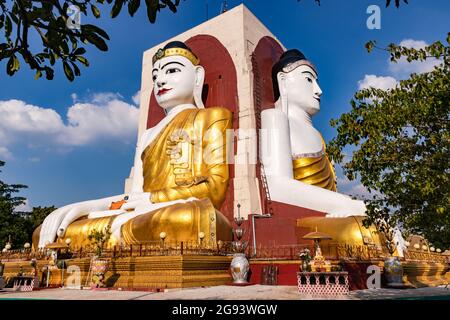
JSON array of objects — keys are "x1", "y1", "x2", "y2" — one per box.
[{"x1": 292, "y1": 139, "x2": 336, "y2": 191}]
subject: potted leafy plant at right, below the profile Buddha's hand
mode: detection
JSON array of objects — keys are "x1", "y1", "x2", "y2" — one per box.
[{"x1": 363, "y1": 204, "x2": 404, "y2": 288}]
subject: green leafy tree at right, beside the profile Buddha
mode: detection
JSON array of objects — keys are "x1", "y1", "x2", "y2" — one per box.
[{"x1": 328, "y1": 33, "x2": 450, "y2": 249}]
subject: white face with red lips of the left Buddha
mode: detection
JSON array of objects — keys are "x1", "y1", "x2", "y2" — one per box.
[{"x1": 152, "y1": 56, "x2": 203, "y2": 109}]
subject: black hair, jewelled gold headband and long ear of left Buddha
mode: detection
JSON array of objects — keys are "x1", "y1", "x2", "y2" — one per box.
[{"x1": 152, "y1": 41, "x2": 205, "y2": 109}]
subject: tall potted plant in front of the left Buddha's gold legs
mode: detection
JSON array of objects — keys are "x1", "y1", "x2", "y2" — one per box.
[{"x1": 88, "y1": 226, "x2": 111, "y2": 288}]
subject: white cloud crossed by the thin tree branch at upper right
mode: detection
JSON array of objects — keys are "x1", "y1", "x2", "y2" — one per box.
[{"x1": 389, "y1": 39, "x2": 442, "y2": 78}]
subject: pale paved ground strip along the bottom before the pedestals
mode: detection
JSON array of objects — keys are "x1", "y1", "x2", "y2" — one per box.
[{"x1": 0, "y1": 285, "x2": 450, "y2": 300}]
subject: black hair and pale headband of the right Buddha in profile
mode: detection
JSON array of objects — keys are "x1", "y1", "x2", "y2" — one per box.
[{"x1": 272, "y1": 49, "x2": 317, "y2": 101}]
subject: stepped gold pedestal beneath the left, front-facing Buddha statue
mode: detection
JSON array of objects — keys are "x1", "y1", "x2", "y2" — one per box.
[{"x1": 0, "y1": 255, "x2": 232, "y2": 290}]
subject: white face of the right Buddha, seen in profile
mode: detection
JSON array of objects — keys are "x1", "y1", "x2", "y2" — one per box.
[{"x1": 278, "y1": 65, "x2": 322, "y2": 116}]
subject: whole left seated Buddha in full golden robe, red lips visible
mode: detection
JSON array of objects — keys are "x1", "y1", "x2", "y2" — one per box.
[{"x1": 33, "y1": 41, "x2": 232, "y2": 248}]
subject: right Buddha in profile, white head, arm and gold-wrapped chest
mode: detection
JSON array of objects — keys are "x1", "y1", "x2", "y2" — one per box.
[{"x1": 260, "y1": 49, "x2": 365, "y2": 217}]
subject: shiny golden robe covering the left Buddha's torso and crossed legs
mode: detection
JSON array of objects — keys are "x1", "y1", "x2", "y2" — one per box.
[{"x1": 33, "y1": 107, "x2": 232, "y2": 247}]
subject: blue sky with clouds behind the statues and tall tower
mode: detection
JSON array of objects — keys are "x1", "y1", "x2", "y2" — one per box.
[{"x1": 0, "y1": 0, "x2": 450, "y2": 206}]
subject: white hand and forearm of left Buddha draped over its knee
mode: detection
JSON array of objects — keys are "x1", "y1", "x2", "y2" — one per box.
[{"x1": 39, "y1": 195, "x2": 123, "y2": 248}]
